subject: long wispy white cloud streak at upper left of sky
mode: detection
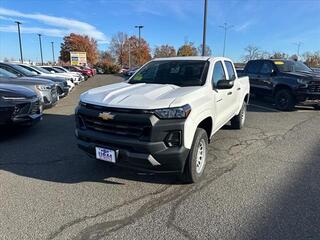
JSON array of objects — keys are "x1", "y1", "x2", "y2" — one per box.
[{"x1": 0, "y1": 8, "x2": 108, "y2": 43}]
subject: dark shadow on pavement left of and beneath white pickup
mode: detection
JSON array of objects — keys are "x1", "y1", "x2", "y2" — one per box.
[{"x1": 0, "y1": 114, "x2": 179, "y2": 184}]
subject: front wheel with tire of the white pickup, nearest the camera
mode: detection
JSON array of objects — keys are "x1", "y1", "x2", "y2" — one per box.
[{"x1": 181, "y1": 128, "x2": 208, "y2": 183}]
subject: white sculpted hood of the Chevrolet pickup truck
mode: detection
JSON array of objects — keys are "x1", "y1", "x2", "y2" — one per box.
[{"x1": 80, "y1": 83, "x2": 200, "y2": 109}]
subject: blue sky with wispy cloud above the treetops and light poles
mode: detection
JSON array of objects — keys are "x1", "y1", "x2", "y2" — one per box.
[{"x1": 0, "y1": 0, "x2": 320, "y2": 61}]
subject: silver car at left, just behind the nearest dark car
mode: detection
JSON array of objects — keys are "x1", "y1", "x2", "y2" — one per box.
[{"x1": 0, "y1": 68, "x2": 59, "y2": 108}]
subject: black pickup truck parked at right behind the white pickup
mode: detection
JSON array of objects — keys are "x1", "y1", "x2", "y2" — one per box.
[{"x1": 238, "y1": 59, "x2": 320, "y2": 111}]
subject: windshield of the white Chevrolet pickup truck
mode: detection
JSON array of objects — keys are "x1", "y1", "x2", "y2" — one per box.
[{"x1": 129, "y1": 60, "x2": 208, "y2": 87}]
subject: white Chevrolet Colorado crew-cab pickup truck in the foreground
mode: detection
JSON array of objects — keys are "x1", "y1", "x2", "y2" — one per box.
[{"x1": 75, "y1": 57, "x2": 250, "y2": 182}]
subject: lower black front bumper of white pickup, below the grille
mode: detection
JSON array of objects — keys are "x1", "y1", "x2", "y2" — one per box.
[{"x1": 76, "y1": 129, "x2": 189, "y2": 173}]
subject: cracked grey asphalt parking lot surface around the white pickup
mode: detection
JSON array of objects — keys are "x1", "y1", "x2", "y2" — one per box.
[{"x1": 0, "y1": 75, "x2": 320, "y2": 240}]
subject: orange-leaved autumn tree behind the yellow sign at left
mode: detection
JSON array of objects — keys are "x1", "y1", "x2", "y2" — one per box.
[{"x1": 60, "y1": 33, "x2": 98, "y2": 65}]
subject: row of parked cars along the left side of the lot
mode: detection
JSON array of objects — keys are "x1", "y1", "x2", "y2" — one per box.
[{"x1": 0, "y1": 62, "x2": 96, "y2": 125}]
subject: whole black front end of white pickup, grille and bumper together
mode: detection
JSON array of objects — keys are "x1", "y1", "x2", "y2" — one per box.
[{"x1": 75, "y1": 107, "x2": 190, "y2": 173}]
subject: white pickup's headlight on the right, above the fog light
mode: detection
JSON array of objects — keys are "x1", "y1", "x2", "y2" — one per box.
[{"x1": 154, "y1": 104, "x2": 191, "y2": 119}]
